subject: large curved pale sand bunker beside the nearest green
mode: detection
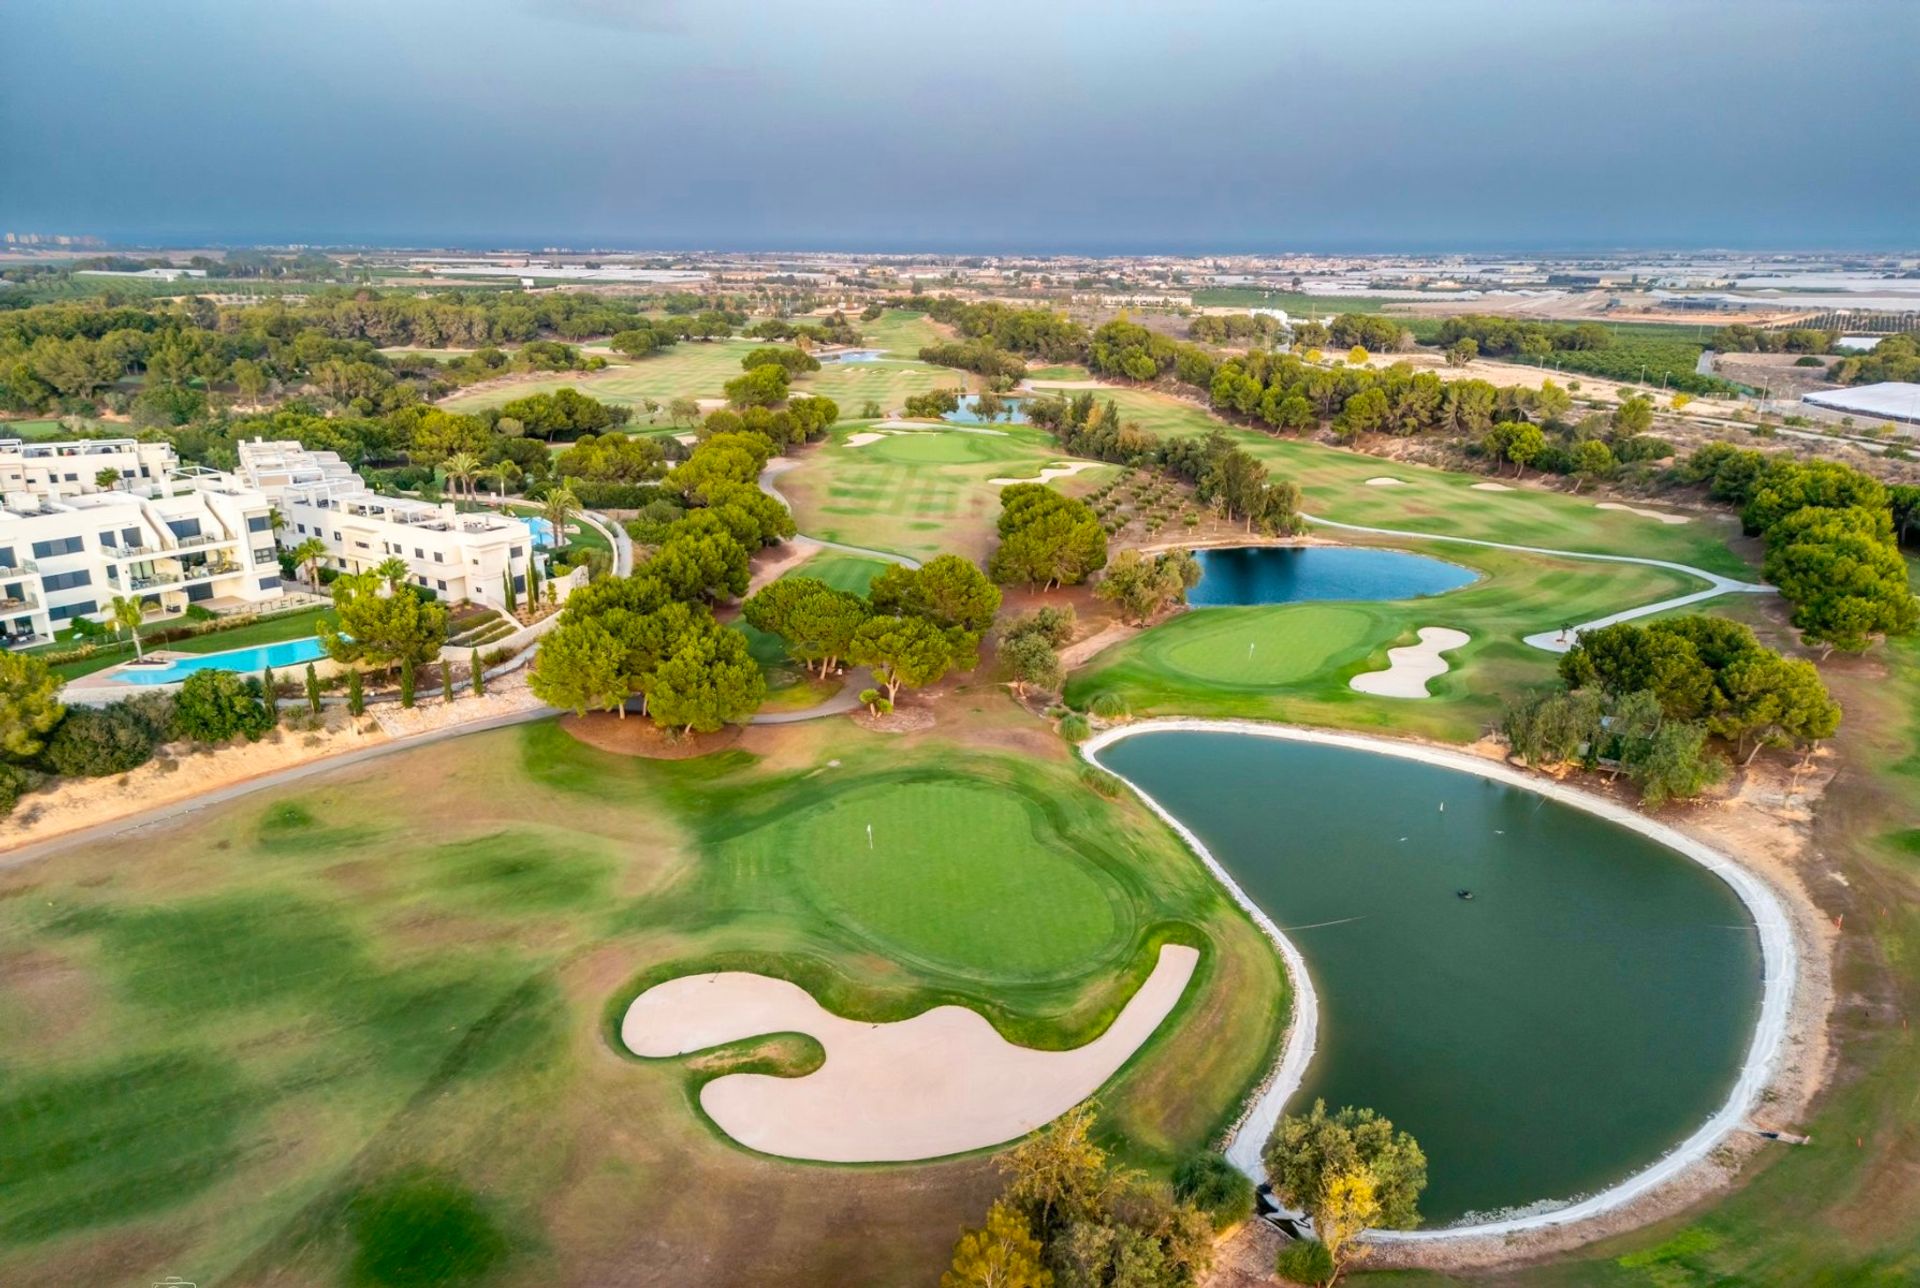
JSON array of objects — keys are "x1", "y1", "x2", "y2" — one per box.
[{"x1": 620, "y1": 944, "x2": 1200, "y2": 1163}]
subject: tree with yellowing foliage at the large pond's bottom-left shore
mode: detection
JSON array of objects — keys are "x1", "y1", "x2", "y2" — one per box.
[{"x1": 1261, "y1": 1100, "x2": 1427, "y2": 1284}]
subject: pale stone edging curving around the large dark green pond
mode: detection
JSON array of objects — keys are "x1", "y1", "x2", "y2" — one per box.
[{"x1": 1081, "y1": 718, "x2": 1799, "y2": 1244}]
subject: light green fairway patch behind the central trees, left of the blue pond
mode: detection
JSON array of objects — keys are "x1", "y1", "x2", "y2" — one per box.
[{"x1": 780, "y1": 424, "x2": 1117, "y2": 561}]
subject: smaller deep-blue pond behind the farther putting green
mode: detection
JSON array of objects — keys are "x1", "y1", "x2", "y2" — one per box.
[{"x1": 1187, "y1": 545, "x2": 1476, "y2": 605}]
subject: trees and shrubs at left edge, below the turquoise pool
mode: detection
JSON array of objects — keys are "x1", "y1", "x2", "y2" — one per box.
[{"x1": 0, "y1": 653, "x2": 278, "y2": 814}]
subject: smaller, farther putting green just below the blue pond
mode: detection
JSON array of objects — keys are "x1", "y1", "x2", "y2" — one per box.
[{"x1": 1146, "y1": 605, "x2": 1380, "y2": 689}]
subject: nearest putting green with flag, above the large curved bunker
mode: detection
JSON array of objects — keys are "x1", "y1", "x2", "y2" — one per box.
[{"x1": 724, "y1": 781, "x2": 1133, "y2": 979}]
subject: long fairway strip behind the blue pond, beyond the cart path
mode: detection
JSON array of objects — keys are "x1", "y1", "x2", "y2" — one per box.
[{"x1": 1100, "y1": 390, "x2": 1755, "y2": 578}]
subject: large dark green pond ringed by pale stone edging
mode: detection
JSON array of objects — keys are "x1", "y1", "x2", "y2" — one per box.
[{"x1": 1100, "y1": 731, "x2": 1763, "y2": 1227}]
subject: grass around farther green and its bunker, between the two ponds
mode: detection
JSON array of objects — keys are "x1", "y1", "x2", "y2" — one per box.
[{"x1": 1068, "y1": 537, "x2": 1699, "y2": 741}]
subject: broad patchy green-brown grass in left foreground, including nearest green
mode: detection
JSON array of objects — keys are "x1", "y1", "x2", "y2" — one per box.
[{"x1": 0, "y1": 706, "x2": 1286, "y2": 1284}]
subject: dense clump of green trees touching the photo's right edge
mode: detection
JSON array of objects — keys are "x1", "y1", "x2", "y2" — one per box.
[{"x1": 1680, "y1": 443, "x2": 1920, "y2": 653}]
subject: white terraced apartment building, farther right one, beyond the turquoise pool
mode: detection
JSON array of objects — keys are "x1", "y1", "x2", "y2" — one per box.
[{"x1": 240, "y1": 440, "x2": 534, "y2": 608}]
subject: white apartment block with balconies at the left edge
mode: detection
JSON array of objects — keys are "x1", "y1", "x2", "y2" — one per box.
[{"x1": 0, "y1": 460, "x2": 284, "y2": 645}]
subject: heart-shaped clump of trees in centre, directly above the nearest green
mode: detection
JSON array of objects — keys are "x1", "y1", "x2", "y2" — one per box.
[{"x1": 743, "y1": 555, "x2": 1000, "y2": 708}]
